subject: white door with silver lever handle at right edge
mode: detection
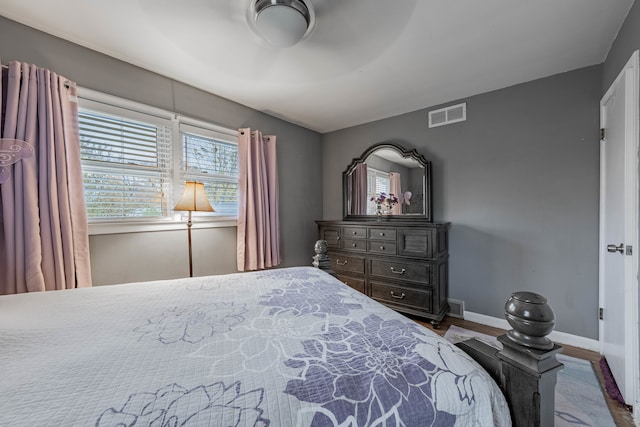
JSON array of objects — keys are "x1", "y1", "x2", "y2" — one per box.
[{"x1": 599, "y1": 48, "x2": 640, "y2": 409}]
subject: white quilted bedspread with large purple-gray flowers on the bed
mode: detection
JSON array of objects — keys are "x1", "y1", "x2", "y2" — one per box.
[{"x1": 0, "y1": 267, "x2": 511, "y2": 427}]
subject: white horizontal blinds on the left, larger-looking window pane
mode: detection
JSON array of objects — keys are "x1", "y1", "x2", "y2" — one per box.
[{"x1": 79, "y1": 109, "x2": 171, "y2": 220}]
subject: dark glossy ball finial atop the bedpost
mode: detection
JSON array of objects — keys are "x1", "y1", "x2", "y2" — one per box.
[{"x1": 504, "y1": 292, "x2": 555, "y2": 350}]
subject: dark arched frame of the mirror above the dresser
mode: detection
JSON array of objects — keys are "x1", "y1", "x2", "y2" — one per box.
[{"x1": 342, "y1": 141, "x2": 433, "y2": 222}]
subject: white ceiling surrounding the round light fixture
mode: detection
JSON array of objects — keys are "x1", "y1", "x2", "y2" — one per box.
[{"x1": 0, "y1": 0, "x2": 633, "y2": 133}]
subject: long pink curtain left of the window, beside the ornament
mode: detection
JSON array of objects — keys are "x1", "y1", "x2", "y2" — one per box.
[{"x1": 0, "y1": 62, "x2": 91, "y2": 294}]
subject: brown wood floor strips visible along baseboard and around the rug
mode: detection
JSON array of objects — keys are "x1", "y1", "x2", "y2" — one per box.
[{"x1": 414, "y1": 317, "x2": 634, "y2": 427}]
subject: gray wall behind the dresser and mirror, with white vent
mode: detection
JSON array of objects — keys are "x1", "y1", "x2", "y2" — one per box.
[{"x1": 322, "y1": 66, "x2": 602, "y2": 339}]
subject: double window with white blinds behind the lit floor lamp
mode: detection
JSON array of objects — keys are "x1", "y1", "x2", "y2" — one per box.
[{"x1": 78, "y1": 90, "x2": 238, "y2": 232}]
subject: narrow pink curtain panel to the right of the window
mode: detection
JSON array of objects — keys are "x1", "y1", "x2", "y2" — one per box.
[{"x1": 238, "y1": 128, "x2": 281, "y2": 271}]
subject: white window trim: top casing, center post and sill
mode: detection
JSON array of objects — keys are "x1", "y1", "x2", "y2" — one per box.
[{"x1": 77, "y1": 87, "x2": 239, "y2": 235}]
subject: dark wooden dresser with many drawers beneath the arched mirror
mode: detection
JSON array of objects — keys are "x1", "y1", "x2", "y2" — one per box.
[{"x1": 316, "y1": 219, "x2": 451, "y2": 327}]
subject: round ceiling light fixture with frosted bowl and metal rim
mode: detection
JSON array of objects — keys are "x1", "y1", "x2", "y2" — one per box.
[{"x1": 248, "y1": 0, "x2": 315, "y2": 47}]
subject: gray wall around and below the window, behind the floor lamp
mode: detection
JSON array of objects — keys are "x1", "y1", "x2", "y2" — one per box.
[{"x1": 0, "y1": 17, "x2": 322, "y2": 284}]
